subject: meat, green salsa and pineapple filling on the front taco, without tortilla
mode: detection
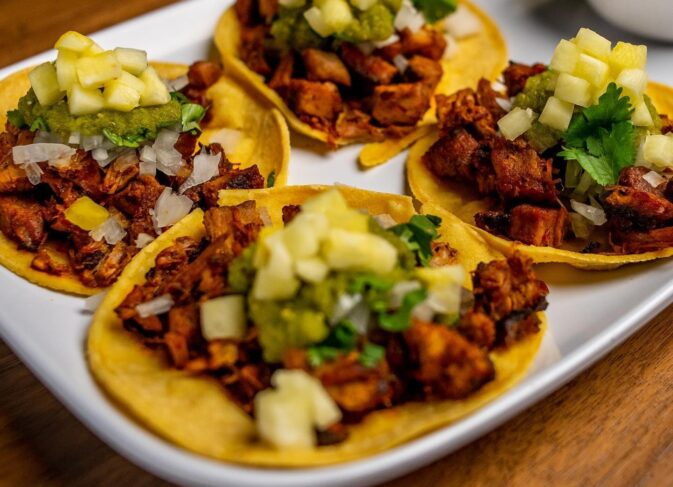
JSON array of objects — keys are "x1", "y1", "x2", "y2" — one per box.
[{"x1": 114, "y1": 190, "x2": 548, "y2": 449}]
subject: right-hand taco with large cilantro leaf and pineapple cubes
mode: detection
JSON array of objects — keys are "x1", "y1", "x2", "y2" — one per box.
[{"x1": 407, "y1": 29, "x2": 673, "y2": 269}]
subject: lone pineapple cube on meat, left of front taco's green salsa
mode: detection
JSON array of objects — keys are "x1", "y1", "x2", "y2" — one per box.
[{"x1": 199, "y1": 295, "x2": 247, "y2": 341}]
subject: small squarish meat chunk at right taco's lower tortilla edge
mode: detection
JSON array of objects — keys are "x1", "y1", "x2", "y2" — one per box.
[{"x1": 508, "y1": 204, "x2": 568, "y2": 247}]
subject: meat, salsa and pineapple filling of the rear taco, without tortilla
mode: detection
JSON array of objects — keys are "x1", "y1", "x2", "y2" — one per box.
[{"x1": 235, "y1": 0, "x2": 482, "y2": 143}]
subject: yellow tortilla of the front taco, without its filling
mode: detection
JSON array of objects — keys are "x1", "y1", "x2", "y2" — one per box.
[{"x1": 87, "y1": 186, "x2": 546, "y2": 467}]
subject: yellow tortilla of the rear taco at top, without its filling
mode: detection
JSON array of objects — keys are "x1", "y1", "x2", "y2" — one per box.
[{"x1": 215, "y1": 0, "x2": 507, "y2": 167}]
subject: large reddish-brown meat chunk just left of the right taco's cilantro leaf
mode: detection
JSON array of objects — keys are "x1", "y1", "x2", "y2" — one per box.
[{"x1": 491, "y1": 137, "x2": 557, "y2": 205}]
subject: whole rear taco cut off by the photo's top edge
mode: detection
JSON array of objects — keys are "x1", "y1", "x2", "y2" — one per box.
[{"x1": 215, "y1": 0, "x2": 507, "y2": 166}]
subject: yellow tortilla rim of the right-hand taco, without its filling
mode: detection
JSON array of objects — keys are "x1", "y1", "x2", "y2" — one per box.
[{"x1": 407, "y1": 83, "x2": 673, "y2": 270}]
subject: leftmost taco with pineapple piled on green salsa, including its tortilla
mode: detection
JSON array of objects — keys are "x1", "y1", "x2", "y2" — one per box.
[{"x1": 0, "y1": 32, "x2": 289, "y2": 295}]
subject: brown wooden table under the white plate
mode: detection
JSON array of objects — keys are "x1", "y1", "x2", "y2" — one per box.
[{"x1": 0, "y1": 0, "x2": 673, "y2": 487}]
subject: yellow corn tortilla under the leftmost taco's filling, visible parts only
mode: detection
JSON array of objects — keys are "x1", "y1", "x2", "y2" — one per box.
[{"x1": 0, "y1": 63, "x2": 290, "y2": 296}]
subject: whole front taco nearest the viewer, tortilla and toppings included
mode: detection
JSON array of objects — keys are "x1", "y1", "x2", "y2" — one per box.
[{"x1": 87, "y1": 186, "x2": 547, "y2": 467}]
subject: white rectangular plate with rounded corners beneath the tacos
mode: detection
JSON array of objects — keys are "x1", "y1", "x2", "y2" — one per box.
[{"x1": 0, "y1": 0, "x2": 673, "y2": 487}]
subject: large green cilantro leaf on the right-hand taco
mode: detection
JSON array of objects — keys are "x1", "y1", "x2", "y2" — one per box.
[{"x1": 559, "y1": 83, "x2": 636, "y2": 186}]
